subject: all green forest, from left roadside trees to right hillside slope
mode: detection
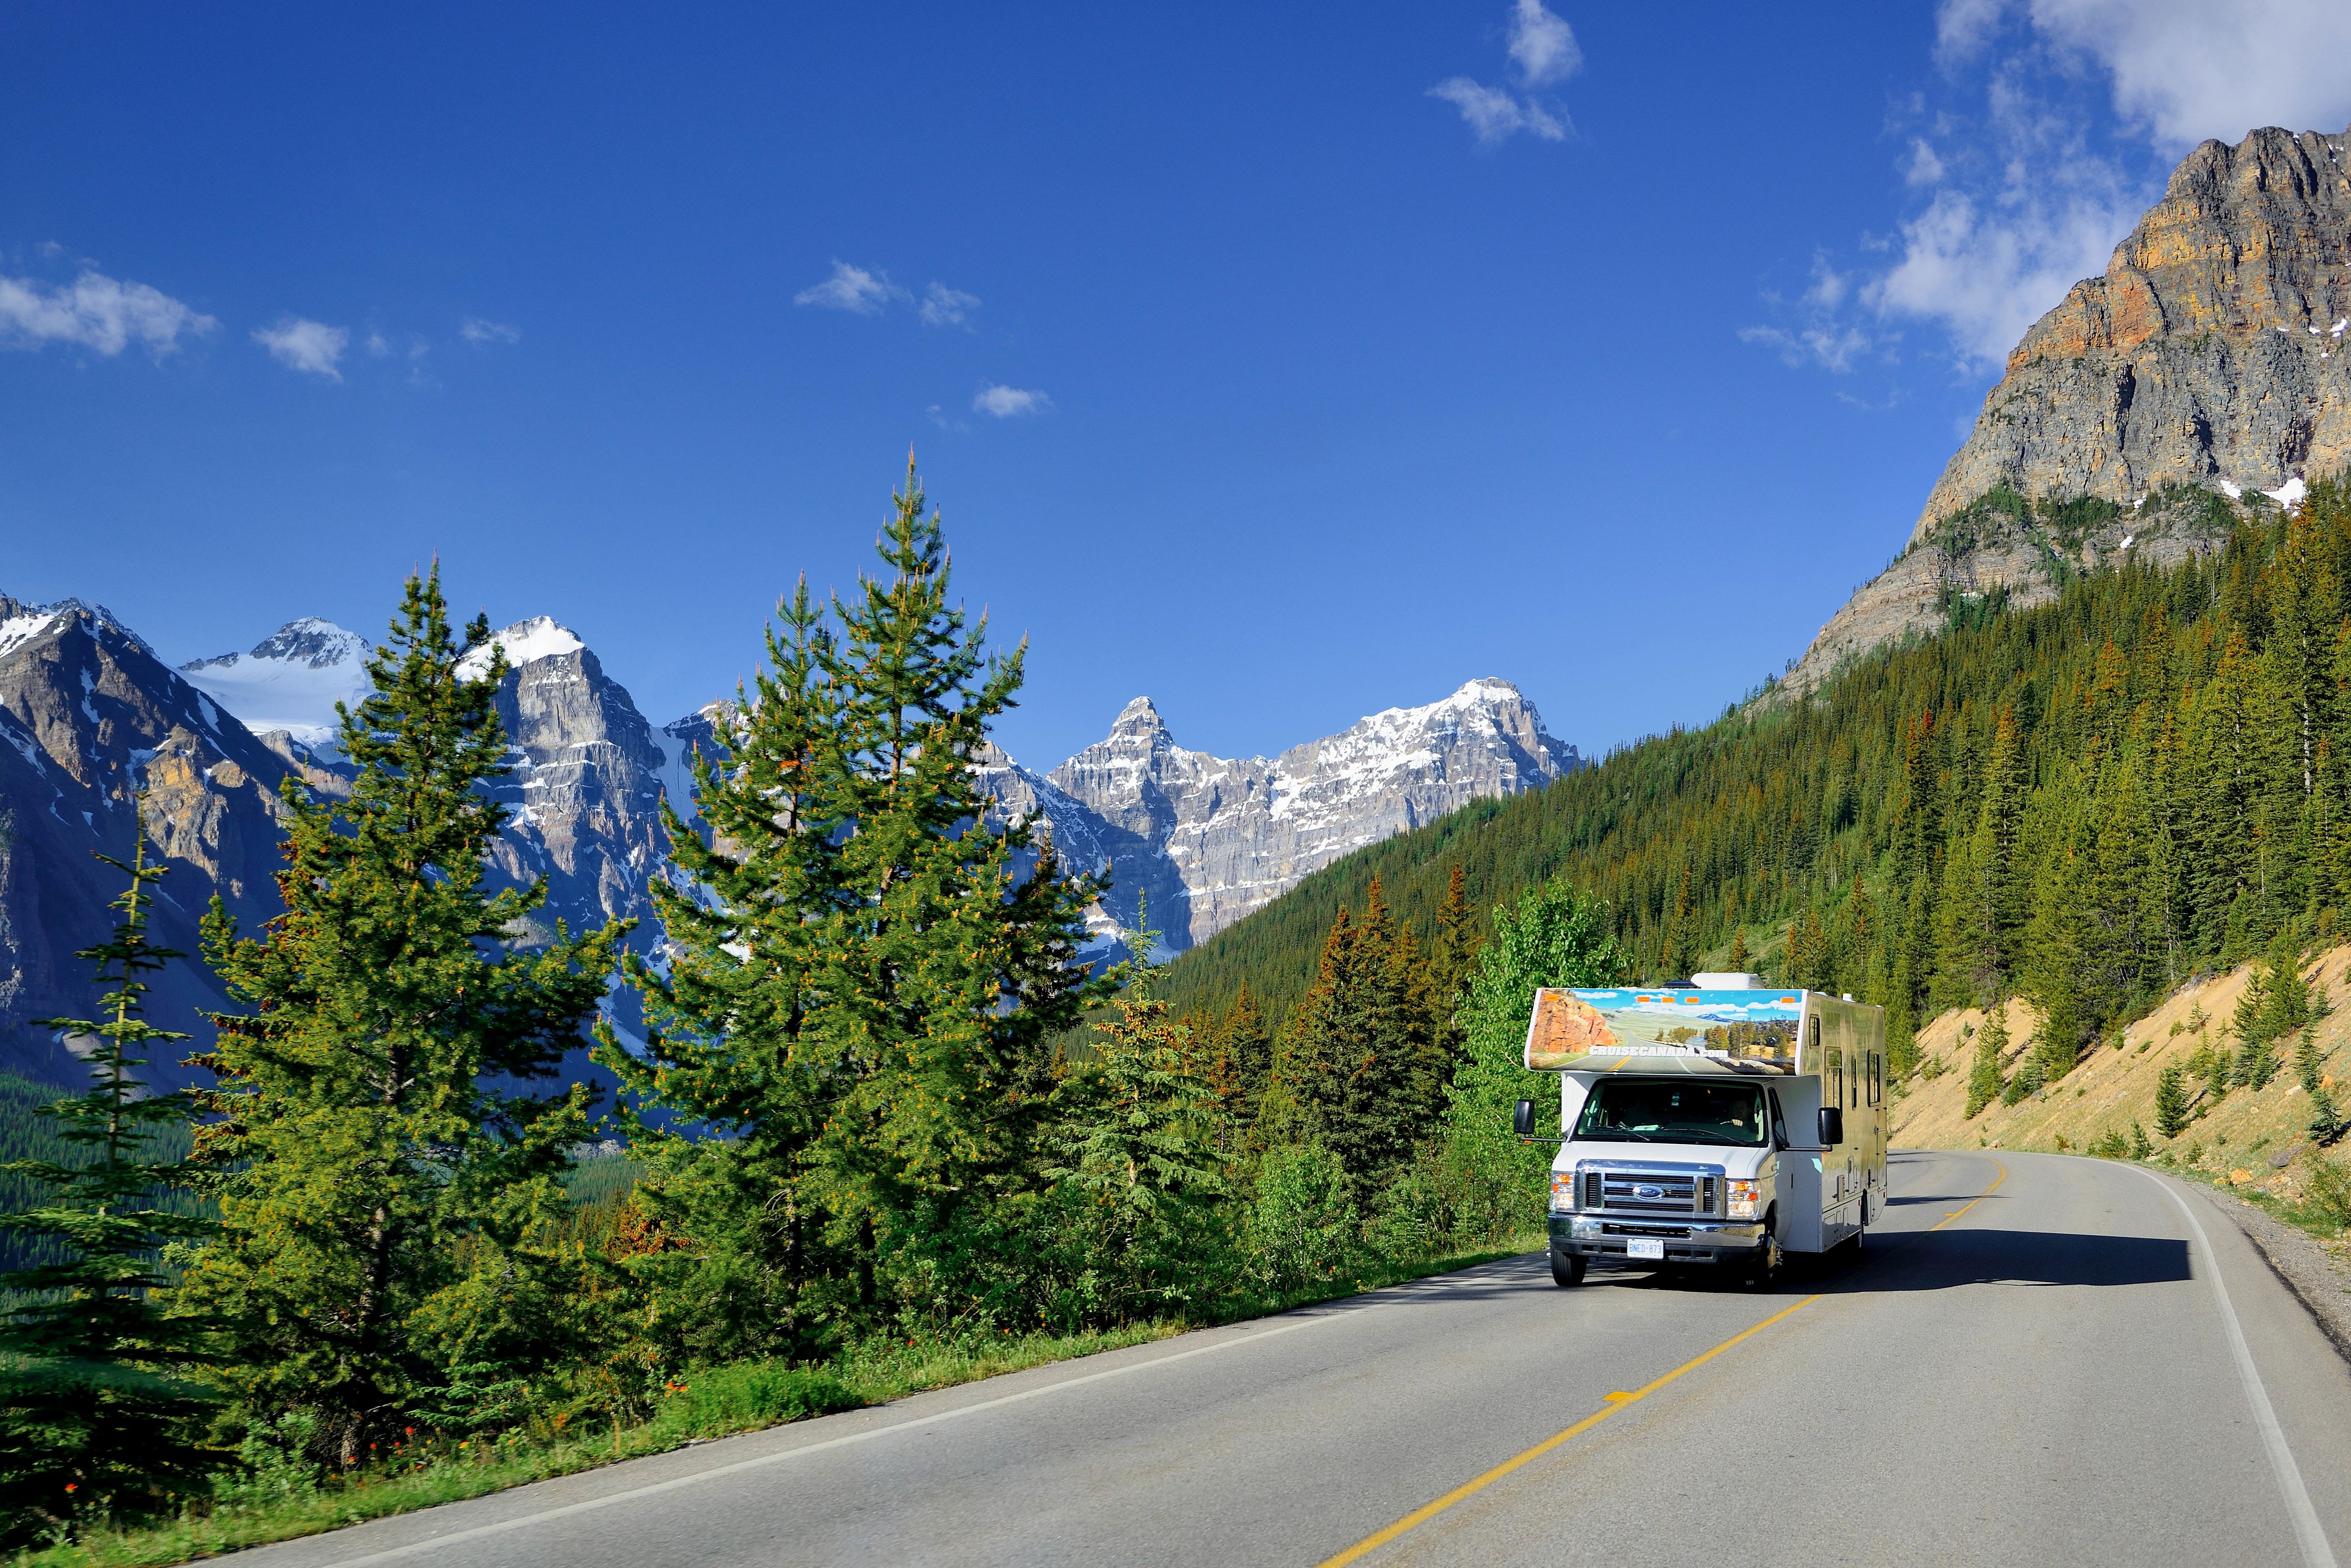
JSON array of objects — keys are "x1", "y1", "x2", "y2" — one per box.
[{"x1": 0, "y1": 470, "x2": 2351, "y2": 1561}]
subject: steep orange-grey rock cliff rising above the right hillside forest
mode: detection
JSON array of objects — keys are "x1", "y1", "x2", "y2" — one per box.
[{"x1": 1791, "y1": 129, "x2": 2351, "y2": 689}]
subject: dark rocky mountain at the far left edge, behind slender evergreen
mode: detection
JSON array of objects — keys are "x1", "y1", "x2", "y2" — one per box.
[{"x1": 0, "y1": 597, "x2": 299, "y2": 1081}]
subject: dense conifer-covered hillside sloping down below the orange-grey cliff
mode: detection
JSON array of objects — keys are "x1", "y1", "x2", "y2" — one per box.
[{"x1": 1166, "y1": 480, "x2": 2351, "y2": 1077}]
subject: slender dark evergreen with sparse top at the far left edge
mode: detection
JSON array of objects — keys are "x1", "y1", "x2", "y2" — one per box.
[{"x1": 0, "y1": 832, "x2": 216, "y2": 1547}]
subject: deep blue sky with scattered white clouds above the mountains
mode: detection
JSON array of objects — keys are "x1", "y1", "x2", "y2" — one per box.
[{"x1": 0, "y1": 0, "x2": 2351, "y2": 766}]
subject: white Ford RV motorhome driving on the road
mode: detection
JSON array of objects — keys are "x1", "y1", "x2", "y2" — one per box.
[{"x1": 1516, "y1": 976, "x2": 1885, "y2": 1286}]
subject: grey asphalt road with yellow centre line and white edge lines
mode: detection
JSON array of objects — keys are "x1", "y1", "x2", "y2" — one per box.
[{"x1": 237, "y1": 1154, "x2": 2351, "y2": 1568}]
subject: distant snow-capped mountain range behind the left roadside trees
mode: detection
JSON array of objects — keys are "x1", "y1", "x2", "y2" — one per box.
[{"x1": 0, "y1": 597, "x2": 1582, "y2": 1079}]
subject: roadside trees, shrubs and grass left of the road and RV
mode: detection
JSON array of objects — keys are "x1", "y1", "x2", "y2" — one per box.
[{"x1": 0, "y1": 470, "x2": 1561, "y2": 1563}]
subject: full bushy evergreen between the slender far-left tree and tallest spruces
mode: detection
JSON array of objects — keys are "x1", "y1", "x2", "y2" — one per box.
[{"x1": 183, "y1": 569, "x2": 625, "y2": 1467}]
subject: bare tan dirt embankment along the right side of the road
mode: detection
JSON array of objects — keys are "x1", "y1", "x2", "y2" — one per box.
[{"x1": 1892, "y1": 945, "x2": 2351, "y2": 1199}]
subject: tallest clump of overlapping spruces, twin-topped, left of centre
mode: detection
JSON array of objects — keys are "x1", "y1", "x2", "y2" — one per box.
[{"x1": 602, "y1": 458, "x2": 1108, "y2": 1345}]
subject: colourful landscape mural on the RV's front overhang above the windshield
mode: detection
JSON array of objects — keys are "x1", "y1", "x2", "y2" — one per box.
[{"x1": 1526, "y1": 990, "x2": 1803, "y2": 1072}]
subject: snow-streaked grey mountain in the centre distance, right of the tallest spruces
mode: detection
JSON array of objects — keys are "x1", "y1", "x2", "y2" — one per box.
[{"x1": 990, "y1": 679, "x2": 1582, "y2": 950}]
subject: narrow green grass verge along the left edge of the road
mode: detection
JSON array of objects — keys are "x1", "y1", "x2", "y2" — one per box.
[{"x1": 12, "y1": 1234, "x2": 1544, "y2": 1568}]
